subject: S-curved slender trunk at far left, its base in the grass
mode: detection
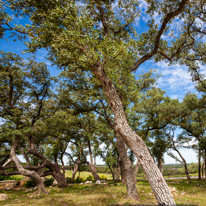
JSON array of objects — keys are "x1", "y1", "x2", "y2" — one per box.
[{"x1": 10, "y1": 137, "x2": 48, "y2": 194}]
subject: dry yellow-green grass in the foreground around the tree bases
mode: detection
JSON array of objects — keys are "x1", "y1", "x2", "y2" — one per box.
[{"x1": 0, "y1": 179, "x2": 206, "y2": 206}]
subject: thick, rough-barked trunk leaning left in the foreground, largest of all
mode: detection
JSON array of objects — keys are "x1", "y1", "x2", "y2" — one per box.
[{"x1": 91, "y1": 65, "x2": 175, "y2": 205}]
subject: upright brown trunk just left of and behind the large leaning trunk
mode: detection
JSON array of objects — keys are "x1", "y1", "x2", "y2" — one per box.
[{"x1": 116, "y1": 133, "x2": 138, "y2": 200}]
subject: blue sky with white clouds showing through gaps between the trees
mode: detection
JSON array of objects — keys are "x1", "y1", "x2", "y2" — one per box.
[{"x1": 0, "y1": 0, "x2": 206, "y2": 164}]
